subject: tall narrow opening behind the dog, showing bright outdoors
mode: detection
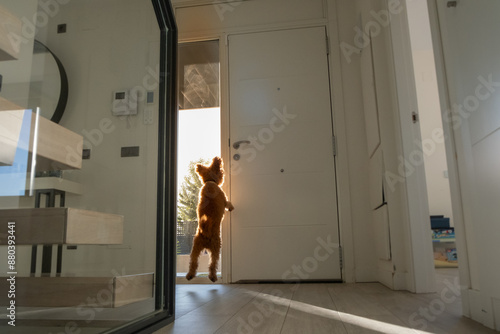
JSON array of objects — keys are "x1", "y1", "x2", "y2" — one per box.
[{"x1": 177, "y1": 40, "x2": 221, "y2": 283}]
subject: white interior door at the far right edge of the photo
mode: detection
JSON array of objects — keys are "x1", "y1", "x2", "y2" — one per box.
[{"x1": 436, "y1": 0, "x2": 500, "y2": 329}]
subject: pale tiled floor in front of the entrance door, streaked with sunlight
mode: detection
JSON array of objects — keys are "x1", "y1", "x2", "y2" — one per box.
[{"x1": 156, "y1": 269, "x2": 497, "y2": 334}]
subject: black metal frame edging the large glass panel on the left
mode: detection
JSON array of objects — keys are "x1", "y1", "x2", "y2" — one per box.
[{"x1": 111, "y1": 0, "x2": 178, "y2": 334}]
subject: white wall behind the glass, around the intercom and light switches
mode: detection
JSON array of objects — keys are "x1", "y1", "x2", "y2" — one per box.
[{"x1": 0, "y1": 0, "x2": 160, "y2": 276}]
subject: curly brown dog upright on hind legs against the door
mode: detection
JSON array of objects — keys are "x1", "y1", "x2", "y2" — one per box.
[{"x1": 186, "y1": 157, "x2": 234, "y2": 282}]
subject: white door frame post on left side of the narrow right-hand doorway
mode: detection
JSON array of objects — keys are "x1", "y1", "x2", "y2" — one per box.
[{"x1": 384, "y1": 0, "x2": 435, "y2": 293}]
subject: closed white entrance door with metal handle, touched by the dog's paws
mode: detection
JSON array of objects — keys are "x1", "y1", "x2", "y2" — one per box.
[{"x1": 229, "y1": 27, "x2": 341, "y2": 282}]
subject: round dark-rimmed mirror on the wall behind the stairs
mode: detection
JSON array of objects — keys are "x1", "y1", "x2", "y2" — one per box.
[{"x1": 28, "y1": 40, "x2": 68, "y2": 123}]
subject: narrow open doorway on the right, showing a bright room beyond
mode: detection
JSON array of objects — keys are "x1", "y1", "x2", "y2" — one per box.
[{"x1": 408, "y1": 1, "x2": 459, "y2": 280}]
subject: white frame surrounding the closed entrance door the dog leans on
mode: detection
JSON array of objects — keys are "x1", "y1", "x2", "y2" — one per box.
[{"x1": 178, "y1": 23, "x2": 350, "y2": 283}]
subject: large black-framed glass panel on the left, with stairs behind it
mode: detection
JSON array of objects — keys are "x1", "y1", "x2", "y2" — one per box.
[{"x1": 0, "y1": 0, "x2": 177, "y2": 333}]
